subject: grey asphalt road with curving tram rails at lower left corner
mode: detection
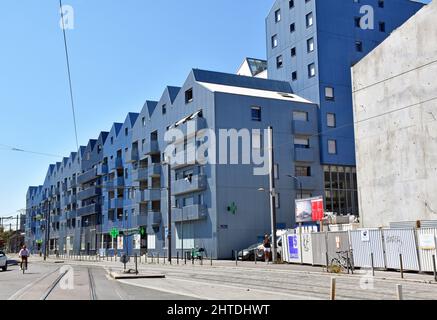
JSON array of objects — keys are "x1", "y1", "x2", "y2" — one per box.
[{"x1": 0, "y1": 261, "x2": 192, "y2": 300}]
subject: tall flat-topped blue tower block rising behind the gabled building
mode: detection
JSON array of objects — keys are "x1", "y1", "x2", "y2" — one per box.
[{"x1": 266, "y1": 0, "x2": 423, "y2": 214}]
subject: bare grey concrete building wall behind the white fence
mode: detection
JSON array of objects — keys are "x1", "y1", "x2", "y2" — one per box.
[{"x1": 352, "y1": 1, "x2": 437, "y2": 227}]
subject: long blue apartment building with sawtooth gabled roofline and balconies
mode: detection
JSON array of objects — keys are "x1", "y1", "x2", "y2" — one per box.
[{"x1": 26, "y1": 69, "x2": 323, "y2": 259}]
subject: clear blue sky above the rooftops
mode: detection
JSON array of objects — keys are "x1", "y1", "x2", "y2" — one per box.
[{"x1": 0, "y1": 0, "x2": 430, "y2": 216}]
